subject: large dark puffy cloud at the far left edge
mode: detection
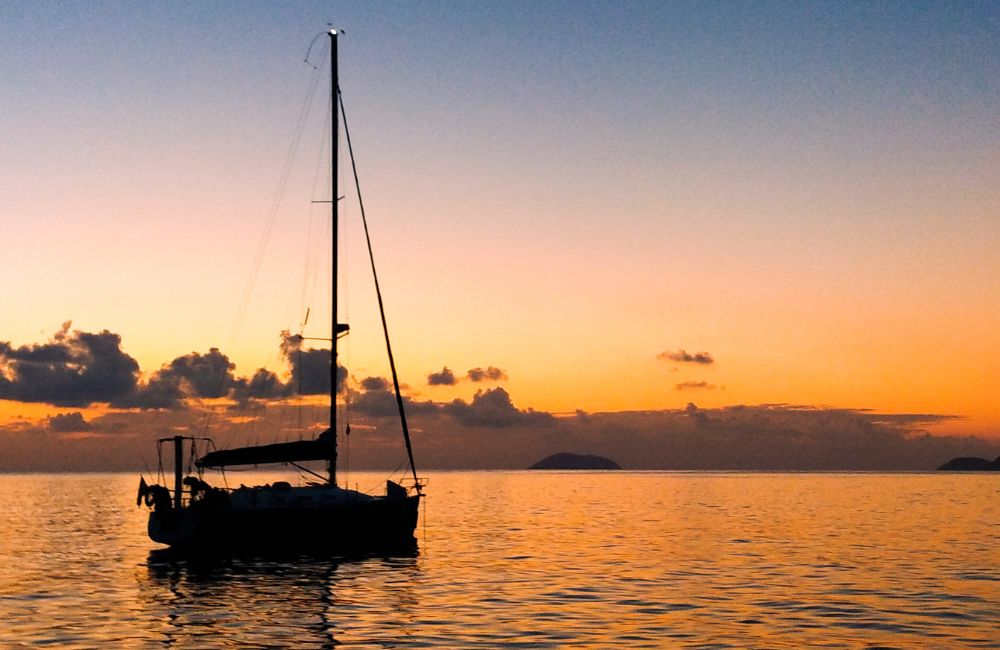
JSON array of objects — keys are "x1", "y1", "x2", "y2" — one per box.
[{"x1": 0, "y1": 322, "x2": 139, "y2": 406}]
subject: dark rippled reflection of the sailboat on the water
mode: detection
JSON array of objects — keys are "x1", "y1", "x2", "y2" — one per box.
[{"x1": 140, "y1": 546, "x2": 419, "y2": 647}]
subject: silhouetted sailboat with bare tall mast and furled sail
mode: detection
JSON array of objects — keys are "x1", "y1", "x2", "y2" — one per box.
[{"x1": 136, "y1": 29, "x2": 424, "y2": 551}]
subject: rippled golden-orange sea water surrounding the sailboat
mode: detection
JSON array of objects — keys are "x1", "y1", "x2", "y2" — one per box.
[{"x1": 0, "y1": 472, "x2": 1000, "y2": 648}]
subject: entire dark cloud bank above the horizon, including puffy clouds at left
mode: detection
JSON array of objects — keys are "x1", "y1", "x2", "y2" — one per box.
[{"x1": 0, "y1": 324, "x2": 1000, "y2": 471}]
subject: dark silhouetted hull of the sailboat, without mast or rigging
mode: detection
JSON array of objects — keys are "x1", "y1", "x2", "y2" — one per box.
[{"x1": 148, "y1": 495, "x2": 420, "y2": 551}]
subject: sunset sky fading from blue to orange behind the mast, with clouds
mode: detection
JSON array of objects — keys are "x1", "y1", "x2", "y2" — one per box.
[{"x1": 0, "y1": 0, "x2": 1000, "y2": 470}]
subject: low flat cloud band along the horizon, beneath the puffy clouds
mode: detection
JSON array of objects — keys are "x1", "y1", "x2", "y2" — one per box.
[{"x1": 0, "y1": 390, "x2": 1000, "y2": 471}]
